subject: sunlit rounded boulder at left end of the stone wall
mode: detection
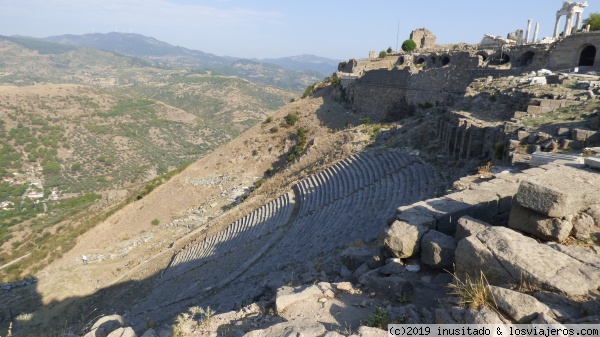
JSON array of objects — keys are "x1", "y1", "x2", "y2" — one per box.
[{"x1": 383, "y1": 221, "x2": 429, "y2": 258}]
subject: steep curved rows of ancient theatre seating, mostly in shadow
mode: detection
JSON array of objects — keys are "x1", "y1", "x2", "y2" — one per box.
[{"x1": 130, "y1": 150, "x2": 437, "y2": 324}]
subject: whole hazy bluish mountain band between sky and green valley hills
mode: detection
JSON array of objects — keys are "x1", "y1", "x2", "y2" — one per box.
[{"x1": 34, "y1": 33, "x2": 339, "y2": 91}]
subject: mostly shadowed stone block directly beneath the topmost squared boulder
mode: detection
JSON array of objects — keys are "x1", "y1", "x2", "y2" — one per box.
[{"x1": 508, "y1": 202, "x2": 573, "y2": 242}]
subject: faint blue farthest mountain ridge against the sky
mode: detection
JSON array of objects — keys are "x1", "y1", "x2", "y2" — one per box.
[{"x1": 42, "y1": 33, "x2": 339, "y2": 76}]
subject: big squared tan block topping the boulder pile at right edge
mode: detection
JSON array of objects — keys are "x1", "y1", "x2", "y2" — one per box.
[{"x1": 516, "y1": 166, "x2": 600, "y2": 217}]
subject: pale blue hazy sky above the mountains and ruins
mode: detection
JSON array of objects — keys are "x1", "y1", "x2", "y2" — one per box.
[{"x1": 0, "y1": 0, "x2": 600, "y2": 60}]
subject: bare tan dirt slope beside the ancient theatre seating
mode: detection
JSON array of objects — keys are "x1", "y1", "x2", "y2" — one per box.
[{"x1": 8, "y1": 89, "x2": 378, "y2": 327}]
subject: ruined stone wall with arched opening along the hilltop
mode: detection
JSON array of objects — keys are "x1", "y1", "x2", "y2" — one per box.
[{"x1": 340, "y1": 28, "x2": 600, "y2": 120}]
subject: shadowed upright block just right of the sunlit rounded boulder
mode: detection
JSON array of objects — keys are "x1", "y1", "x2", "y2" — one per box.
[{"x1": 421, "y1": 230, "x2": 456, "y2": 270}]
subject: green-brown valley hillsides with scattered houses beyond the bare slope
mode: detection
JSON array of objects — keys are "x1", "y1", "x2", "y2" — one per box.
[{"x1": 0, "y1": 39, "x2": 294, "y2": 281}]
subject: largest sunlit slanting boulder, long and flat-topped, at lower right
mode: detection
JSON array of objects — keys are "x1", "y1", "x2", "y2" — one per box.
[{"x1": 456, "y1": 227, "x2": 600, "y2": 296}]
